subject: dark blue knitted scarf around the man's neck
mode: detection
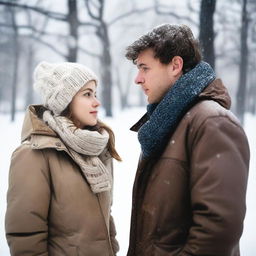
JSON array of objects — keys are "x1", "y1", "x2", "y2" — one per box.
[{"x1": 138, "y1": 62, "x2": 215, "y2": 157}]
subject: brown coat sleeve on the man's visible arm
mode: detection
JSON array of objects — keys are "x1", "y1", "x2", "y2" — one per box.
[{"x1": 181, "y1": 117, "x2": 249, "y2": 256}]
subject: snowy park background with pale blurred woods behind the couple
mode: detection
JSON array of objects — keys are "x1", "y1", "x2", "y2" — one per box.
[{"x1": 0, "y1": 0, "x2": 256, "y2": 256}]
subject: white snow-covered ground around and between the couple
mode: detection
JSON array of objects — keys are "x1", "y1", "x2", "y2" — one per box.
[{"x1": 0, "y1": 108, "x2": 256, "y2": 256}]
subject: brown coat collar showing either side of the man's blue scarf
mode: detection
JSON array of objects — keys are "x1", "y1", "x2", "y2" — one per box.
[{"x1": 130, "y1": 78, "x2": 231, "y2": 132}]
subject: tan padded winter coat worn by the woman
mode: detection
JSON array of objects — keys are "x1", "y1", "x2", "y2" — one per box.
[{"x1": 5, "y1": 106, "x2": 118, "y2": 256}]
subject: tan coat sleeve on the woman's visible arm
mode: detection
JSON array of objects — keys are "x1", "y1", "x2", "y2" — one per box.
[{"x1": 5, "y1": 145, "x2": 50, "y2": 256}]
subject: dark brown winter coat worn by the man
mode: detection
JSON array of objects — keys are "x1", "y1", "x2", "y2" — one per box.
[{"x1": 128, "y1": 79, "x2": 249, "y2": 256}]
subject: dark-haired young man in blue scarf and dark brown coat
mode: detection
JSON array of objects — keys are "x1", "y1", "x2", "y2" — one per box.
[{"x1": 126, "y1": 24, "x2": 249, "y2": 256}]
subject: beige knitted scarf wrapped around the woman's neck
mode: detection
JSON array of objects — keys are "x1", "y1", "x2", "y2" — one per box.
[{"x1": 43, "y1": 110, "x2": 112, "y2": 193}]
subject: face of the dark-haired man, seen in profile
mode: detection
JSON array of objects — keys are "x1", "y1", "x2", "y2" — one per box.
[{"x1": 135, "y1": 48, "x2": 176, "y2": 104}]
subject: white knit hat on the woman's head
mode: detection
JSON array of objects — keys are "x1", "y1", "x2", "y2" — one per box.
[{"x1": 34, "y1": 61, "x2": 98, "y2": 115}]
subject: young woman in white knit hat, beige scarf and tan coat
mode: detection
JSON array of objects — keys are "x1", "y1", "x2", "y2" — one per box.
[{"x1": 5, "y1": 62, "x2": 121, "y2": 256}]
